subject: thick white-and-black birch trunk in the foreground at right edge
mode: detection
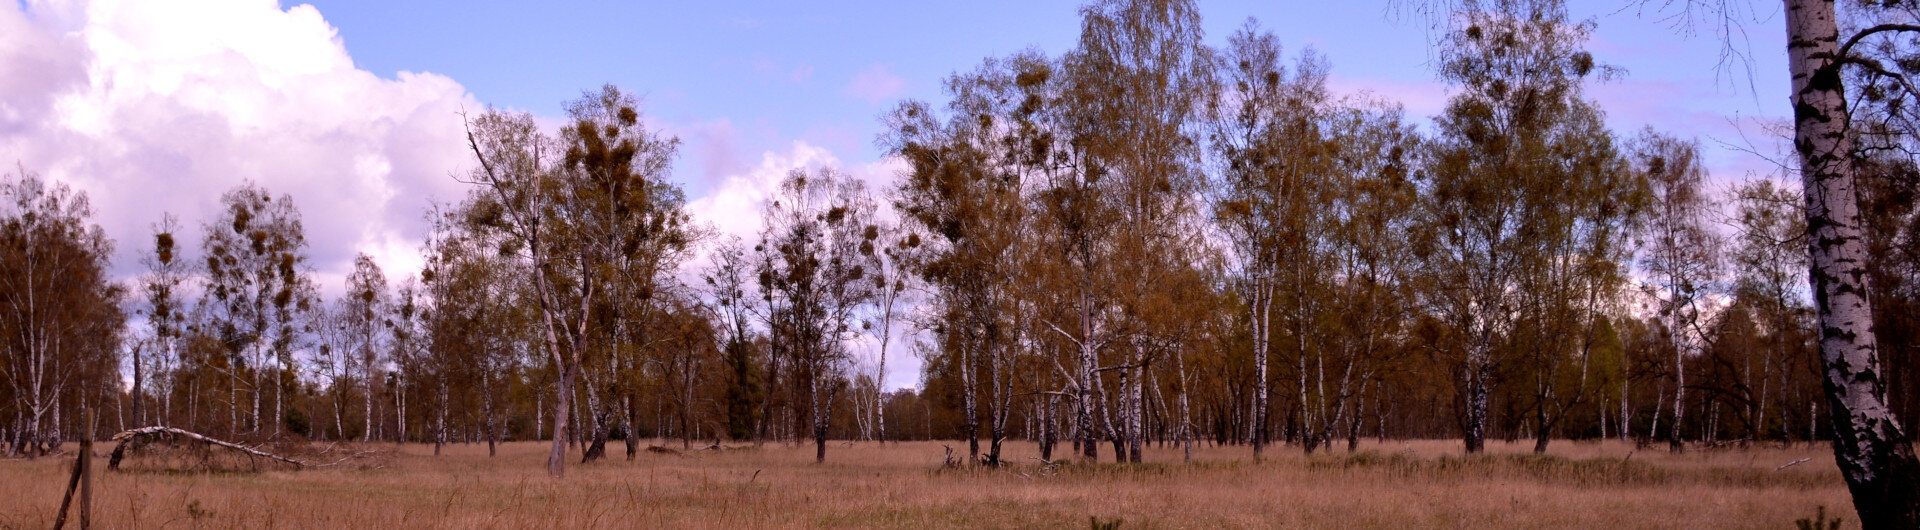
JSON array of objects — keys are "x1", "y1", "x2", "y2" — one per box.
[{"x1": 1786, "y1": 0, "x2": 1920, "y2": 528}]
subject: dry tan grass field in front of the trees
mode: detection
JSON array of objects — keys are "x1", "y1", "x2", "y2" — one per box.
[{"x1": 0, "y1": 440, "x2": 1855, "y2": 528}]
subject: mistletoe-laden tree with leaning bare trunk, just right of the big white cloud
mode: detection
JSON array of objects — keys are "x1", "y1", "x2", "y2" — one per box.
[{"x1": 467, "y1": 84, "x2": 695, "y2": 476}]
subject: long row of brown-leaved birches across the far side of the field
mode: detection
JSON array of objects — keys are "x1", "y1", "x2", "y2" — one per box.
[{"x1": 0, "y1": 0, "x2": 1920, "y2": 474}]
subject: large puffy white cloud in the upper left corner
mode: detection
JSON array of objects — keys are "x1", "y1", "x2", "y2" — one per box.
[{"x1": 0, "y1": 0, "x2": 482, "y2": 292}]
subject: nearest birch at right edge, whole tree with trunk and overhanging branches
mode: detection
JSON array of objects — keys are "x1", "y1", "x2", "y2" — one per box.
[{"x1": 1417, "y1": 0, "x2": 1920, "y2": 518}]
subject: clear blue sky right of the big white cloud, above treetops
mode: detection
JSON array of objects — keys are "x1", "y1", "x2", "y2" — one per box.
[{"x1": 313, "y1": 0, "x2": 1786, "y2": 200}]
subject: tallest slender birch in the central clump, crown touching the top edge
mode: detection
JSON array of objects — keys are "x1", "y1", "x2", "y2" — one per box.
[{"x1": 1062, "y1": 0, "x2": 1213, "y2": 463}]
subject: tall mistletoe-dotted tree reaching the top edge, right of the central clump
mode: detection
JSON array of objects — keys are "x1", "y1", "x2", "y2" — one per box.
[{"x1": 1415, "y1": 2, "x2": 1609, "y2": 451}]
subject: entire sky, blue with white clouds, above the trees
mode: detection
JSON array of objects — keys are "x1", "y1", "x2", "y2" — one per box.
[{"x1": 0, "y1": 0, "x2": 1788, "y2": 388}]
